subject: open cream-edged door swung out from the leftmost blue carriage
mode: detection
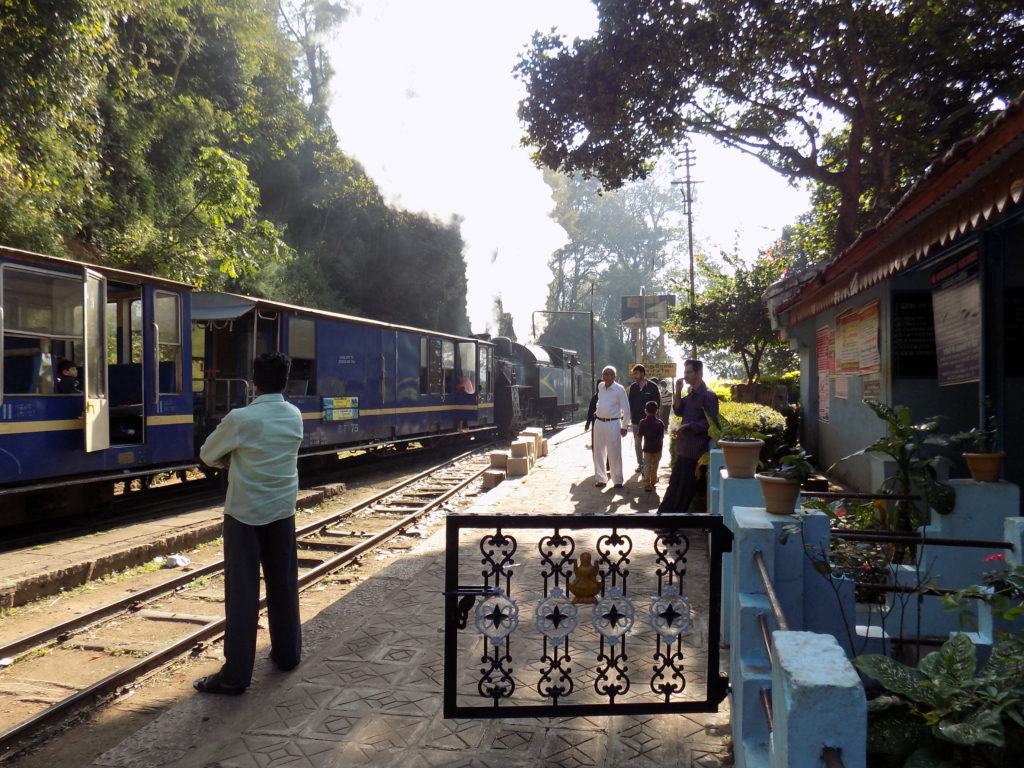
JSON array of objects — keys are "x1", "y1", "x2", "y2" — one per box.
[{"x1": 82, "y1": 269, "x2": 111, "y2": 452}]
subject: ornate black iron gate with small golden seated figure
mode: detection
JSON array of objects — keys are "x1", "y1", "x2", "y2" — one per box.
[{"x1": 444, "y1": 514, "x2": 732, "y2": 718}]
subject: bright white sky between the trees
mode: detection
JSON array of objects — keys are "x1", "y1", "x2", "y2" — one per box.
[{"x1": 331, "y1": 0, "x2": 808, "y2": 340}]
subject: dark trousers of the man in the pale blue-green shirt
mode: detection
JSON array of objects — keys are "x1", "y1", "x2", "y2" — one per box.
[{"x1": 220, "y1": 515, "x2": 302, "y2": 688}]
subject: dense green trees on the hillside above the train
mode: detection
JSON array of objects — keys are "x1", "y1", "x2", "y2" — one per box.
[{"x1": 0, "y1": 0, "x2": 469, "y2": 333}]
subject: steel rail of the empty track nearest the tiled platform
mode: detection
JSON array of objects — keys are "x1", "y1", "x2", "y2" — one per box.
[{"x1": 0, "y1": 452, "x2": 487, "y2": 761}]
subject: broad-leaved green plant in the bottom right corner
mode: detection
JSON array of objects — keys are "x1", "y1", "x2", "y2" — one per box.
[{"x1": 854, "y1": 633, "x2": 1024, "y2": 766}]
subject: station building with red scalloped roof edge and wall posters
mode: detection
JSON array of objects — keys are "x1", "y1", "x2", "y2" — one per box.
[{"x1": 767, "y1": 96, "x2": 1024, "y2": 505}]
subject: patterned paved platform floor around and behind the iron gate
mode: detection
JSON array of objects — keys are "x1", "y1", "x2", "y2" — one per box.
[{"x1": 92, "y1": 426, "x2": 730, "y2": 768}]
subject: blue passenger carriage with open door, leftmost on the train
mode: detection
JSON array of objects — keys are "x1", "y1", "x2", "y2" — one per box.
[{"x1": 0, "y1": 247, "x2": 196, "y2": 522}]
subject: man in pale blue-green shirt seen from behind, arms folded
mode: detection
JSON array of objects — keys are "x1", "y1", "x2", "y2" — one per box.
[{"x1": 195, "y1": 352, "x2": 302, "y2": 695}]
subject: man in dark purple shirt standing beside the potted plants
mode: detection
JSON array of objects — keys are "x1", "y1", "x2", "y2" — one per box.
[{"x1": 657, "y1": 360, "x2": 718, "y2": 514}]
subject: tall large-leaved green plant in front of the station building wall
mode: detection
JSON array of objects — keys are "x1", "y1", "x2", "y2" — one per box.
[{"x1": 829, "y1": 399, "x2": 956, "y2": 531}]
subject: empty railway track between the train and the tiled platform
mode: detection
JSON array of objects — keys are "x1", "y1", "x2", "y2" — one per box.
[{"x1": 0, "y1": 450, "x2": 487, "y2": 762}]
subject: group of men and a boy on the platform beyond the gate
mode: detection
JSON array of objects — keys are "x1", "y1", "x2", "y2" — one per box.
[{"x1": 584, "y1": 360, "x2": 718, "y2": 514}]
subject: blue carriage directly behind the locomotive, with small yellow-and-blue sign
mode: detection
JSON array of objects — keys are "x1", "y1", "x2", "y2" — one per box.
[{"x1": 193, "y1": 292, "x2": 494, "y2": 456}]
